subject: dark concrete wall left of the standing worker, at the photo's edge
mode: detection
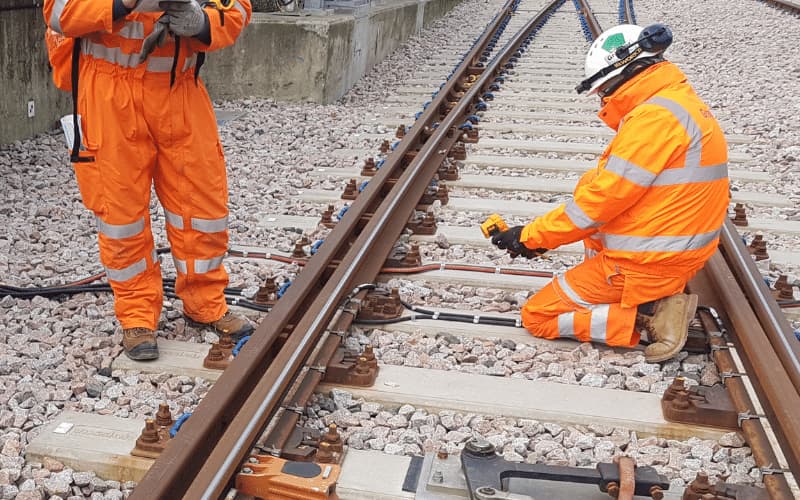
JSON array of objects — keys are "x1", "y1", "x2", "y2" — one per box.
[{"x1": 0, "y1": 0, "x2": 71, "y2": 144}]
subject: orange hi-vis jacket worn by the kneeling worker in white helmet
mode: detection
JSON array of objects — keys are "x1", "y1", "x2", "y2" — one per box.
[{"x1": 520, "y1": 61, "x2": 730, "y2": 306}]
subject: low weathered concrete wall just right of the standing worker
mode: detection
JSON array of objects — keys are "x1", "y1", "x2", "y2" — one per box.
[{"x1": 202, "y1": 0, "x2": 460, "y2": 104}]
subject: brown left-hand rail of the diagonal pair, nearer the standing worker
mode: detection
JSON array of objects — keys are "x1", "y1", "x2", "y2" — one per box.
[{"x1": 132, "y1": 0, "x2": 532, "y2": 500}]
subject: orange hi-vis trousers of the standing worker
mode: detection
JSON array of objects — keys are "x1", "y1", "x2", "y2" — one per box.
[{"x1": 73, "y1": 62, "x2": 228, "y2": 329}]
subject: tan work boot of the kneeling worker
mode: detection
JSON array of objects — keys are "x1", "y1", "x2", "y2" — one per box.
[{"x1": 636, "y1": 293, "x2": 697, "y2": 363}]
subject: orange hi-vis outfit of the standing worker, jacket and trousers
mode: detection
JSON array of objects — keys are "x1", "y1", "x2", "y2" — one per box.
[{"x1": 44, "y1": 0, "x2": 251, "y2": 330}]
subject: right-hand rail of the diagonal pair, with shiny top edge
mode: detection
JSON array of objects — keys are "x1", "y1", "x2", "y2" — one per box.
[{"x1": 185, "y1": 0, "x2": 564, "y2": 499}]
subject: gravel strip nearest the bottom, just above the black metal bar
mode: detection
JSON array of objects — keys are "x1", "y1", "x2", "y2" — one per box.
[{"x1": 304, "y1": 390, "x2": 760, "y2": 487}]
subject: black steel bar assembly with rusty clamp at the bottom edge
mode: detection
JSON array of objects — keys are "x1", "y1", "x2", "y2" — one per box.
[{"x1": 415, "y1": 440, "x2": 680, "y2": 500}]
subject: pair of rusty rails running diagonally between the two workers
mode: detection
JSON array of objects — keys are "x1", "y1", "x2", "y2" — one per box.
[{"x1": 132, "y1": 0, "x2": 564, "y2": 500}]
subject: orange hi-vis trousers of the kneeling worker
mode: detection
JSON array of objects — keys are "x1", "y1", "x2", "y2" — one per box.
[{"x1": 521, "y1": 250, "x2": 688, "y2": 347}]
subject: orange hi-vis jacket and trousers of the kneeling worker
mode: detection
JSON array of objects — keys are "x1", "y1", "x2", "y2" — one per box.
[{"x1": 520, "y1": 61, "x2": 730, "y2": 347}]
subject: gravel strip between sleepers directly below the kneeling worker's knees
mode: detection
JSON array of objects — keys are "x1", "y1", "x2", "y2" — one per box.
[{"x1": 357, "y1": 330, "x2": 721, "y2": 395}]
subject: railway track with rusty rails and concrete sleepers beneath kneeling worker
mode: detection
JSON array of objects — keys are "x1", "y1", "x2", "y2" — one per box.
[{"x1": 6, "y1": 0, "x2": 800, "y2": 499}]
